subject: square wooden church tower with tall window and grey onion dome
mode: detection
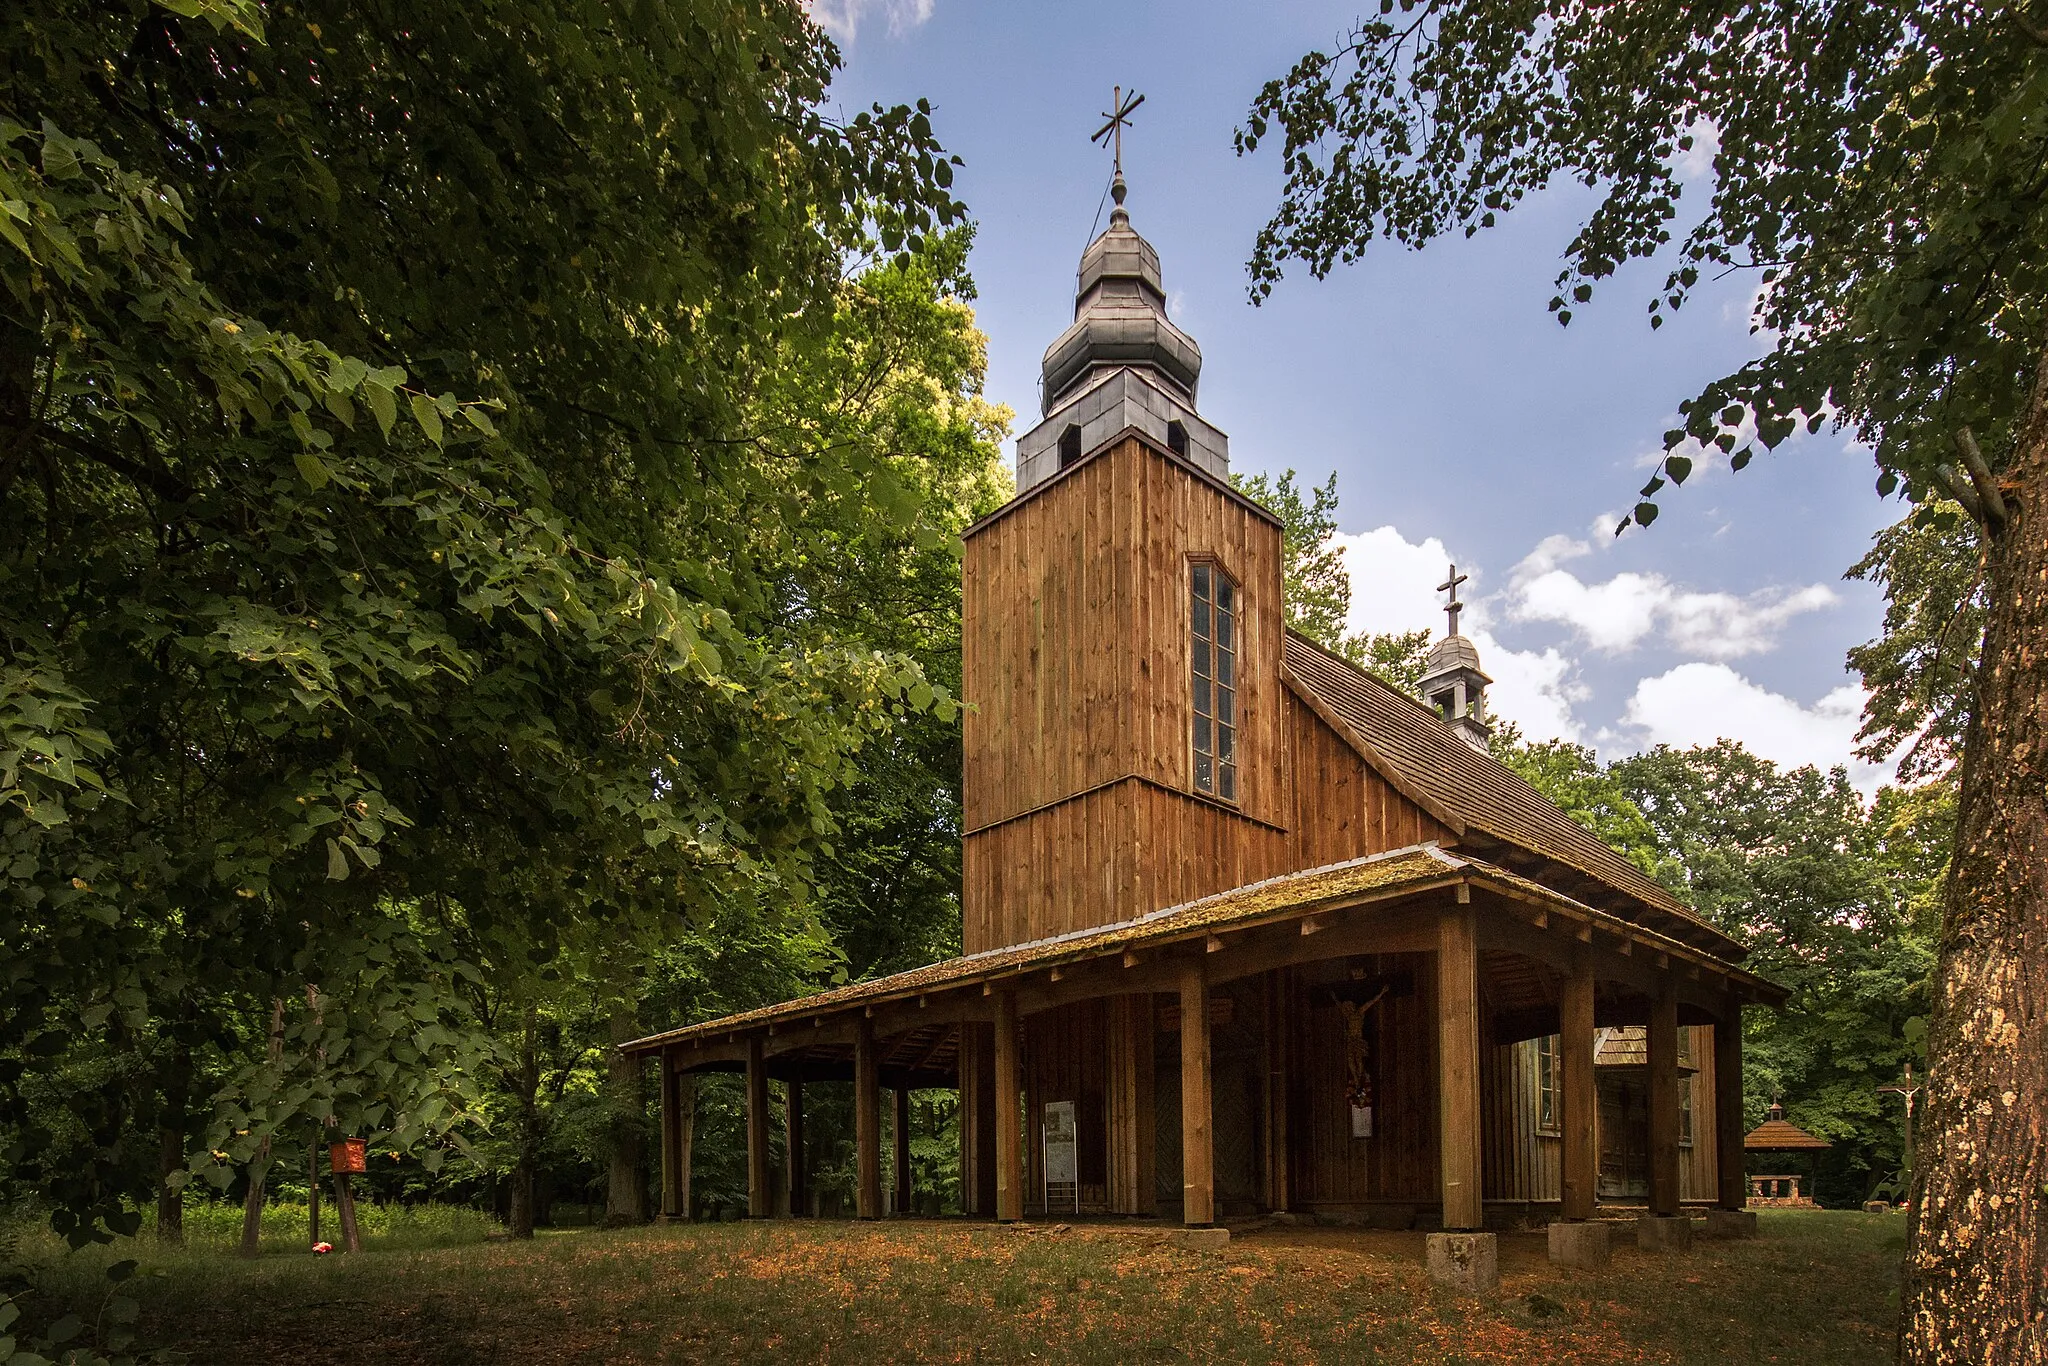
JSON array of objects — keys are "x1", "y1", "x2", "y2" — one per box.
[{"x1": 963, "y1": 170, "x2": 1290, "y2": 952}]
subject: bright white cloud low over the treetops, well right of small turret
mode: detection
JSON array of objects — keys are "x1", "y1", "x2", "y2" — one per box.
[{"x1": 1622, "y1": 664, "x2": 1892, "y2": 797}]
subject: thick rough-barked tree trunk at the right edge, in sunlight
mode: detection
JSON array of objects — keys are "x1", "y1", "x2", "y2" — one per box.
[{"x1": 1901, "y1": 352, "x2": 2048, "y2": 1366}]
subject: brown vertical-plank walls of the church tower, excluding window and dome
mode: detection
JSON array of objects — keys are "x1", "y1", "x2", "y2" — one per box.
[{"x1": 963, "y1": 438, "x2": 1292, "y2": 952}]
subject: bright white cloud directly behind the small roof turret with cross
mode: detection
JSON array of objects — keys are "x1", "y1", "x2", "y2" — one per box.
[{"x1": 1335, "y1": 526, "x2": 1589, "y2": 739}]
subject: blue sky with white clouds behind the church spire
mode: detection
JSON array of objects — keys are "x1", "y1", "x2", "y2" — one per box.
[{"x1": 811, "y1": 0, "x2": 1903, "y2": 793}]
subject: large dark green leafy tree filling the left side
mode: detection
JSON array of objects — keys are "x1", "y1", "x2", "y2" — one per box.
[{"x1": 0, "y1": 0, "x2": 963, "y2": 1239}]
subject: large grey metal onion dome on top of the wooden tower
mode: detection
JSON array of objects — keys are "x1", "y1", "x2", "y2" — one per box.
[{"x1": 1018, "y1": 157, "x2": 1231, "y2": 494}]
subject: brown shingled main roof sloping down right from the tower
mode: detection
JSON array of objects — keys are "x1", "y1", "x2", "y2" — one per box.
[{"x1": 1284, "y1": 631, "x2": 1745, "y2": 963}]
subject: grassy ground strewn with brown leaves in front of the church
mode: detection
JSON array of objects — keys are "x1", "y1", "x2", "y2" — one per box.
[{"x1": 16, "y1": 1212, "x2": 1903, "y2": 1366}]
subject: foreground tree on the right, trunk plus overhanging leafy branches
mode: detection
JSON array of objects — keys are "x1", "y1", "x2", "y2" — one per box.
[{"x1": 1237, "y1": 0, "x2": 2048, "y2": 1362}]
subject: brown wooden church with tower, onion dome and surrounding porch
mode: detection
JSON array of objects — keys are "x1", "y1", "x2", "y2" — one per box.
[{"x1": 627, "y1": 162, "x2": 1782, "y2": 1231}]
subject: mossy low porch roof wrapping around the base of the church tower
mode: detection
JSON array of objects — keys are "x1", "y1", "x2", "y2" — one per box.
[{"x1": 621, "y1": 842, "x2": 1784, "y2": 1053}]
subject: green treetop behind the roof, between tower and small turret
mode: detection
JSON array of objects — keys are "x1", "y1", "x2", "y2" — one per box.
[{"x1": 1231, "y1": 469, "x2": 1430, "y2": 698}]
